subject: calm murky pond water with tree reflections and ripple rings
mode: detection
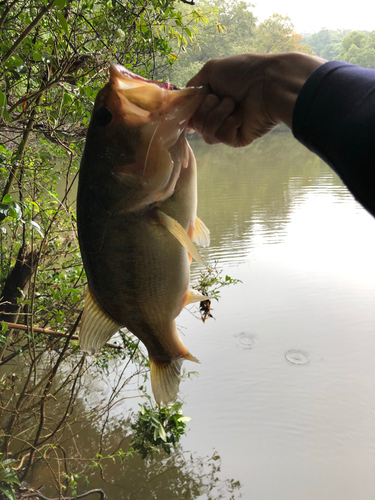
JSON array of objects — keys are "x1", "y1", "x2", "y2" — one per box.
[{"x1": 35, "y1": 133, "x2": 375, "y2": 500}]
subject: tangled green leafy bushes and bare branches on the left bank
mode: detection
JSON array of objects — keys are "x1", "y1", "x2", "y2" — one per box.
[{"x1": 0, "y1": 0, "x2": 244, "y2": 499}]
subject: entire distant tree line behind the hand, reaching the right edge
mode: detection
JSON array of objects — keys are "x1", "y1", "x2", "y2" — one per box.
[{"x1": 157, "y1": 0, "x2": 375, "y2": 85}]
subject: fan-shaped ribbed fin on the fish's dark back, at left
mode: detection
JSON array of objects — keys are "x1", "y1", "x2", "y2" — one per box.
[{"x1": 79, "y1": 288, "x2": 122, "y2": 354}]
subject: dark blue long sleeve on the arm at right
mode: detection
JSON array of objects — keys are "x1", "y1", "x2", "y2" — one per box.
[{"x1": 293, "y1": 61, "x2": 375, "y2": 216}]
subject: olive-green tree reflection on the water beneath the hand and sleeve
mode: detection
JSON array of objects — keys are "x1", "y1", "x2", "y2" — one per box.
[{"x1": 193, "y1": 133, "x2": 360, "y2": 266}]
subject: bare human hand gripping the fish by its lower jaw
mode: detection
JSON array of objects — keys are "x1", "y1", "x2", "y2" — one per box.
[{"x1": 187, "y1": 53, "x2": 325, "y2": 147}]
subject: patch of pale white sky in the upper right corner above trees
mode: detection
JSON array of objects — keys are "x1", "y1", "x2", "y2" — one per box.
[{"x1": 250, "y1": 0, "x2": 375, "y2": 33}]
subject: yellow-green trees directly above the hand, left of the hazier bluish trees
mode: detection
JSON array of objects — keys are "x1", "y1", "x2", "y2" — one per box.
[{"x1": 158, "y1": 0, "x2": 313, "y2": 85}]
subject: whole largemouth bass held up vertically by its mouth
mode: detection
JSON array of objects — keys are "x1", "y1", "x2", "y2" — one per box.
[{"x1": 77, "y1": 65, "x2": 210, "y2": 405}]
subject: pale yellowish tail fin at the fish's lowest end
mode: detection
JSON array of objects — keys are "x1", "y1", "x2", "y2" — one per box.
[{"x1": 150, "y1": 351, "x2": 199, "y2": 405}]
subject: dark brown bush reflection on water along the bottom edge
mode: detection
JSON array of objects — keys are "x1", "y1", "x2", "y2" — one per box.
[{"x1": 28, "y1": 390, "x2": 241, "y2": 500}]
